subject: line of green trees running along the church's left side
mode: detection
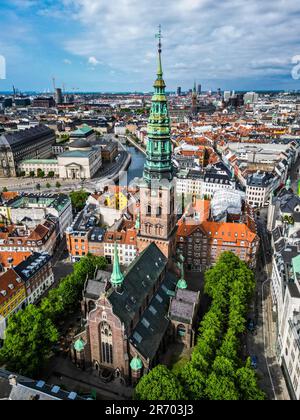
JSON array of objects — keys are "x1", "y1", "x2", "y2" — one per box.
[{"x1": 0, "y1": 255, "x2": 107, "y2": 377}]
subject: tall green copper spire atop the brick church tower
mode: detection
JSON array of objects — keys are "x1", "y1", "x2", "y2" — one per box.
[{"x1": 144, "y1": 27, "x2": 173, "y2": 182}]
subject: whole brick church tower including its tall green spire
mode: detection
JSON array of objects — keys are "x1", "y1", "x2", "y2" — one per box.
[{"x1": 137, "y1": 28, "x2": 177, "y2": 261}]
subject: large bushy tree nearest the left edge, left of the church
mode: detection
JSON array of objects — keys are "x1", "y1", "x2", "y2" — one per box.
[{"x1": 0, "y1": 305, "x2": 58, "y2": 377}]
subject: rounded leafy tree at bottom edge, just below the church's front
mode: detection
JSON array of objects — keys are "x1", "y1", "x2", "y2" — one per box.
[{"x1": 135, "y1": 365, "x2": 186, "y2": 401}]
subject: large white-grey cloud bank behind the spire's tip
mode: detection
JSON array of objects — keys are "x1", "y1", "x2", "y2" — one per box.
[{"x1": 58, "y1": 0, "x2": 300, "y2": 87}]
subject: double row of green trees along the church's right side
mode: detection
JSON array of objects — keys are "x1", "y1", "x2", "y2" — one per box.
[{"x1": 172, "y1": 252, "x2": 264, "y2": 400}]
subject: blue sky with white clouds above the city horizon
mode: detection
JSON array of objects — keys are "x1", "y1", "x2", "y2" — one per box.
[{"x1": 0, "y1": 0, "x2": 300, "y2": 92}]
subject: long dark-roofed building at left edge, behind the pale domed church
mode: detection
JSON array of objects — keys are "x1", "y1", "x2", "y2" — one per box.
[{"x1": 0, "y1": 125, "x2": 56, "y2": 178}]
